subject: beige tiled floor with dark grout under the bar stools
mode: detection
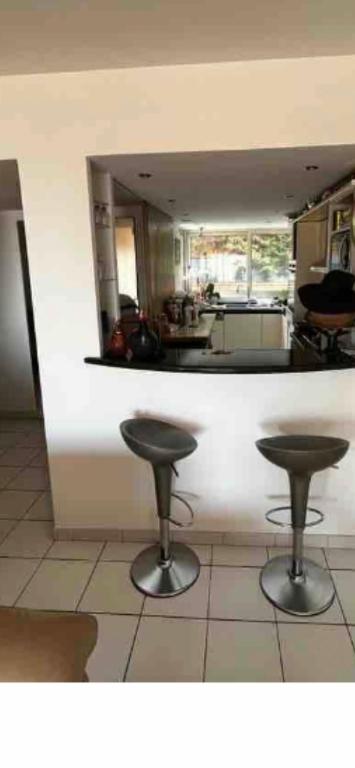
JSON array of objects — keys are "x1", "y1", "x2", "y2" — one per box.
[{"x1": 0, "y1": 421, "x2": 355, "y2": 682}]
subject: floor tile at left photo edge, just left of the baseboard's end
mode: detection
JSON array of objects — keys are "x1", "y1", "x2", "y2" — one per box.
[{"x1": 0, "y1": 520, "x2": 53, "y2": 557}]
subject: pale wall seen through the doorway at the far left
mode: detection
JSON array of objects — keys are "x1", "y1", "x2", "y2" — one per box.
[{"x1": 0, "y1": 211, "x2": 36, "y2": 412}]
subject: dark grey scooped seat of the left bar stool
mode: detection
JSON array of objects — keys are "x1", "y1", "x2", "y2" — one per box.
[{"x1": 121, "y1": 419, "x2": 197, "y2": 464}]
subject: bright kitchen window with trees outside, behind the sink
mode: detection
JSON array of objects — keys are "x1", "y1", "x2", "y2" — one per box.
[{"x1": 189, "y1": 230, "x2": 291, "y2": 298}]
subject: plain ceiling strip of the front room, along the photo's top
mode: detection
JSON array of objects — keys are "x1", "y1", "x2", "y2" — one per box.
[{"x1": 0, "y1": 0, "x2": 355, "y2": 75}]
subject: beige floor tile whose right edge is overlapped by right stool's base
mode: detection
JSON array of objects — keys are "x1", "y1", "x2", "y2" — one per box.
[{"x1": 210, "y1": 566, "x2": 274, "y2": 621}]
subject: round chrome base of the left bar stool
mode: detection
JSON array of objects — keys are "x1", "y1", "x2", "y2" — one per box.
[{"x1": 131, "y1": 542, "x2": 200, "y2": 597}]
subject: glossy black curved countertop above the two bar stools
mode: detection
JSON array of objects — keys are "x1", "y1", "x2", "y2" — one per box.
[{"x1": 85, "y1": 344, "x2": 355, "y2": 373}]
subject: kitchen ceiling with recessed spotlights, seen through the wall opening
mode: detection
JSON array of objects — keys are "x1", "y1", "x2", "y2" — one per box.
[{"x1": 94, "y1": 145, "x2": 355, "y2": 229}]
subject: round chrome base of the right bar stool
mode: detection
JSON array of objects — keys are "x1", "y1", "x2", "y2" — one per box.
[{"x1": 260, "y1": 555, "x2": 335, "y2": 616}]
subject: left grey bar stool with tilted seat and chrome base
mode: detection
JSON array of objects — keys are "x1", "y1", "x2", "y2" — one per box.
[{"x1": 120, "y1": 419, "x2": 200, "y2": 597}]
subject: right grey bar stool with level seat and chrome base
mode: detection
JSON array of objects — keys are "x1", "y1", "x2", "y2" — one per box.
[{"x1": 256, "y1": 435, "x2": 349, "y2": 616}]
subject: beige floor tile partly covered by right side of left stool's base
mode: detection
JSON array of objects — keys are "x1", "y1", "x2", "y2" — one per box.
[{"x1": 143, "y1": 566, "x2": 210, "y2": 619}]
